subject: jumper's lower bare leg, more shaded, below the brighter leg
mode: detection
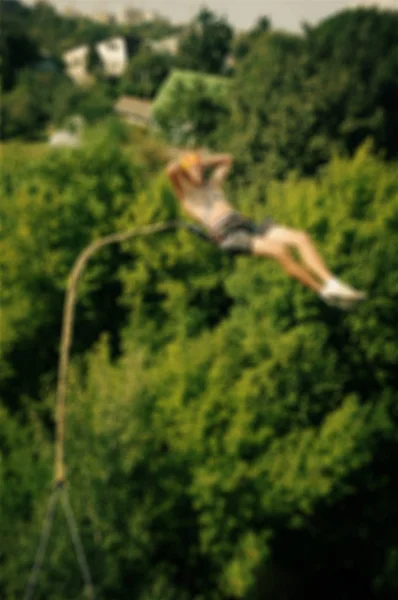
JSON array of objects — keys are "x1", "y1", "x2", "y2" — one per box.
[{"x1": 253, "y1": 236, "x2": 322, "y2": 293}]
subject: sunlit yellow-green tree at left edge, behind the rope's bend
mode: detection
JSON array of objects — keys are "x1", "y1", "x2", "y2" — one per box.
[{"x1": 1, "y1": 126, "x2": 166, "y2": 407}]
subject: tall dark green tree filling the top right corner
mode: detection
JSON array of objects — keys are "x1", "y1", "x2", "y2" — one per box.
[{"x1": 306, "y1": 8, "x2": 398, "y2": 158}]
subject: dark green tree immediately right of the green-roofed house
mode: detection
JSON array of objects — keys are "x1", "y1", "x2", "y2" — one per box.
[{"x1": 221, "y1": 32, "x2": 302, "y2": 180}]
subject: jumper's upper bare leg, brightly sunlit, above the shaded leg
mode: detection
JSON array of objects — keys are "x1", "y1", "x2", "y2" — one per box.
[{"x1": 265, "y1": 226, "x2": 333, "y2": 283}]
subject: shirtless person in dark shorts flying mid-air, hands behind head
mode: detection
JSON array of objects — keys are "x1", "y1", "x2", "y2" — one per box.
[{"x1": 167, "y1": 152, "x2": 366, "y2": 309}]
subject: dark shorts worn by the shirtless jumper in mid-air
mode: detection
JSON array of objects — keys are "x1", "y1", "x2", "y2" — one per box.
[{"x1": 214, "y1": 213, "x2": 275, "y2": 254}]
